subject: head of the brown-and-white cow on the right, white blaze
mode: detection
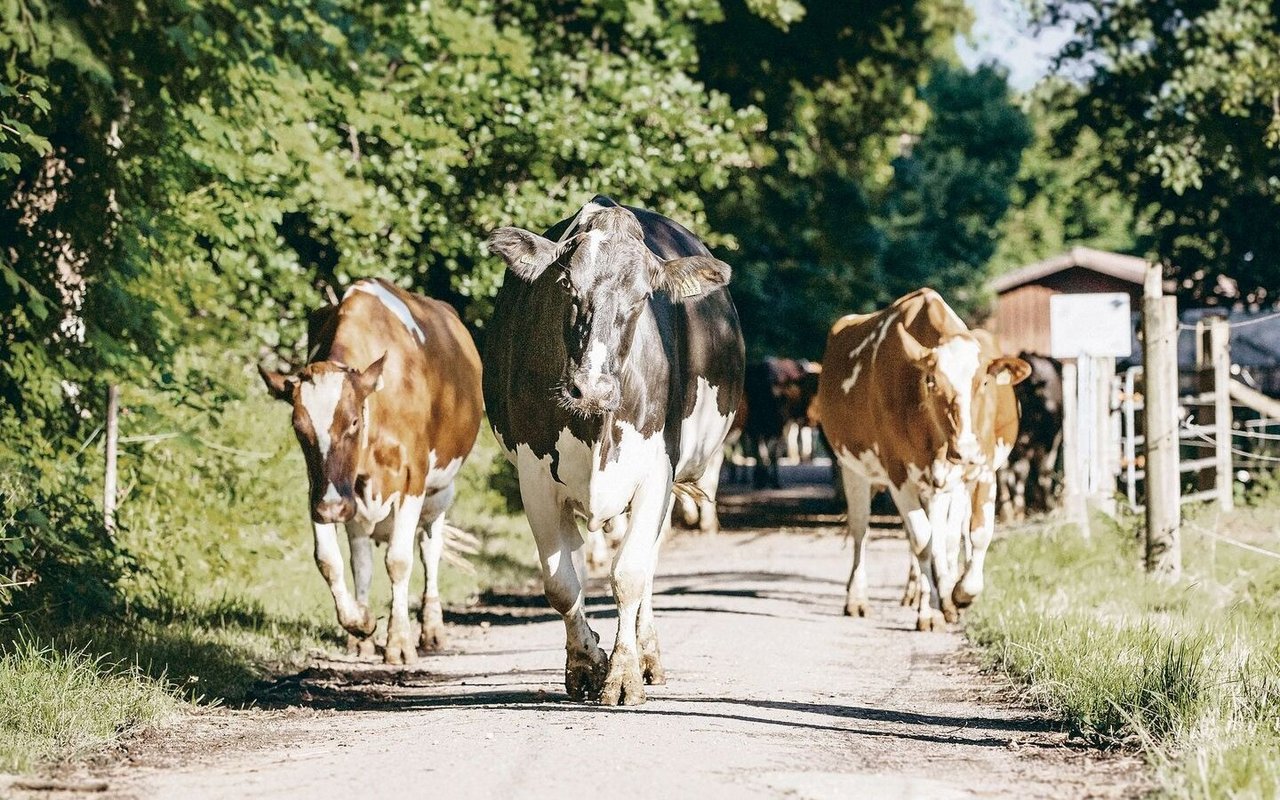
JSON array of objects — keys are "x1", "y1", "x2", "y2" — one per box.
[{"x1": 897, "y1": 324, "x2": 1025, "y2": 473}]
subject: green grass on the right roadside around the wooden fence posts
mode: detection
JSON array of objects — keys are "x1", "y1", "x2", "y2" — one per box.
[{"x1": 968, "y1": 494, "x2": 1280, "y2": 797}]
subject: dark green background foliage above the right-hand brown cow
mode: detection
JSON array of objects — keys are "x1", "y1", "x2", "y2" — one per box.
[{"x1": 699, "y1": 0, "x2": 1029, "y2": 358}]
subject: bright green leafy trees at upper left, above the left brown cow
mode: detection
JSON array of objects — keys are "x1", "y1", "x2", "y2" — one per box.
[{"x1": 0, "y1": 0, "x2": 757, "y2": 604}]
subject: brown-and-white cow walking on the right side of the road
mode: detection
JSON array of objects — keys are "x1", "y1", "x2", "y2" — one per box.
[{"x1": 818, "y1": 289, "x2": 1024, "y2": 630}]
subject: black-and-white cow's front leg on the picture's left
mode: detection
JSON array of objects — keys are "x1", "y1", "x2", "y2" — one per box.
[{"x1": 520, "y1": 467, "x2": 609, "y2": 700}]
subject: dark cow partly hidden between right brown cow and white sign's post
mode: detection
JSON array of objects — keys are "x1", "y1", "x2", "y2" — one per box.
[{"x1": 998, "y1": 352, "x2": 1062, "y2": 520}]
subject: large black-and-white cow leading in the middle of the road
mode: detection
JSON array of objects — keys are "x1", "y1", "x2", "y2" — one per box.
[{"x1": 484, "y1": 197, "x2": 745, "y2": 705}]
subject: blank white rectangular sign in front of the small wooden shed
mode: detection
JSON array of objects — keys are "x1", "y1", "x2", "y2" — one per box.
[{"x1": 1048, "y1": 292, "x2": 1133, "y2": 358}]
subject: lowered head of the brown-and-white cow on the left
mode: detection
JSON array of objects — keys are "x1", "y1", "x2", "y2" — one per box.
[{"x1": 259, "y1": 356, "x2": 385, "y2": 522}]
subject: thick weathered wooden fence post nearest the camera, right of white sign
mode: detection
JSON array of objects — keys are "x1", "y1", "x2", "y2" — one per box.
[{"x1": 1142, "y1": 264, "x2": 1183, "y2": 580}]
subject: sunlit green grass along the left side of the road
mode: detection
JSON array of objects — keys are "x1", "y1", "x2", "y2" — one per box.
[{"x1": 0, "y1": 386, "x2": 538, "y2": 772}]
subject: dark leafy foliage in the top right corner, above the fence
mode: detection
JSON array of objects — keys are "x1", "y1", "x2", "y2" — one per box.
[{"x1": 1038, "y1": 0, "x2": 1280, "y2": 305}]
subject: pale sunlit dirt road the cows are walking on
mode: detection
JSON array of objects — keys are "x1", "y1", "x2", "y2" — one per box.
[{"x1": 87, "y1": 476, "x2": 1140, "y2": 800}]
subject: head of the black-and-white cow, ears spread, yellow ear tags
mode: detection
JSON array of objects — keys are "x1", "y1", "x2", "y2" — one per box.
[{"x1": 489, "y1": 205, "x2": 730, "y2": 416}]
